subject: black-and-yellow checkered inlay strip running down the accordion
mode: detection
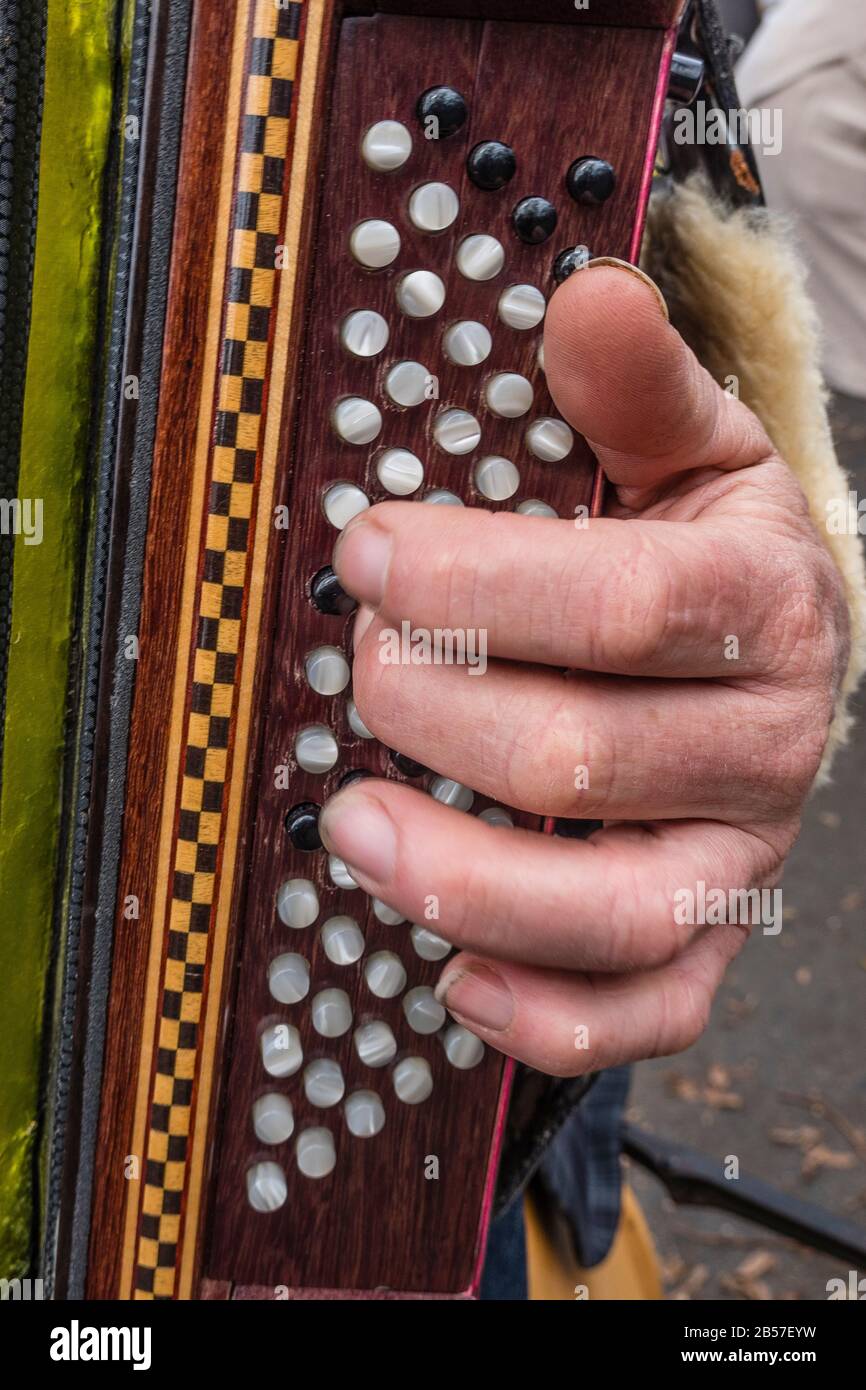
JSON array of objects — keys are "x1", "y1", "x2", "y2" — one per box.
[{"x1": 133, "y1": 0, "x2": 300, "y2": 1298}]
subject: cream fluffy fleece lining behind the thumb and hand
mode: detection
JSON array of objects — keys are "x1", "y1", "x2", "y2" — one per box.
[{"x1": 642, "y1": 177, "x2": 866, "y2": 783}]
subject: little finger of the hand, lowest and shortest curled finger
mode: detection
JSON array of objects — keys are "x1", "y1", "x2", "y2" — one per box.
[{"x1": 436, "y1": 924, "x2": 745, "y2": 1076}]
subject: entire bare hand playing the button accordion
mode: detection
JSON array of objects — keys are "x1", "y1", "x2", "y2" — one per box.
[{"x1": 321, "y1": 265, "x2": 848, "y2": 1076}]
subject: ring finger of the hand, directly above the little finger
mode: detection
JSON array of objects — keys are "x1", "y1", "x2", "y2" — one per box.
[{"x1": 320, "y1": 781, "x2": 778, "y2": 970}]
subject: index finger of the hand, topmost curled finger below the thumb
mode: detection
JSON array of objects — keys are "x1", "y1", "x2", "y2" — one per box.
[{"x1": 334, "y1": 502, "x2": 778, "y2": 677}]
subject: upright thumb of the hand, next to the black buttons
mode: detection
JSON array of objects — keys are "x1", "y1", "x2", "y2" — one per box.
[{"x1": 545, "y1": 259, "x2": 773, "y2": 488}]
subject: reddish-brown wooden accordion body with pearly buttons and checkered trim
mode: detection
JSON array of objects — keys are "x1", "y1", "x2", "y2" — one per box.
[{"x1": 57, "y1": 0, "x2": 681, "y2": 1298}]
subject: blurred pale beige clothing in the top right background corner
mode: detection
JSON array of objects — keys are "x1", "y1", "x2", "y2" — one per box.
[{"x1": 737, "y1": 0, "x2": 866, "y2": 398}]
